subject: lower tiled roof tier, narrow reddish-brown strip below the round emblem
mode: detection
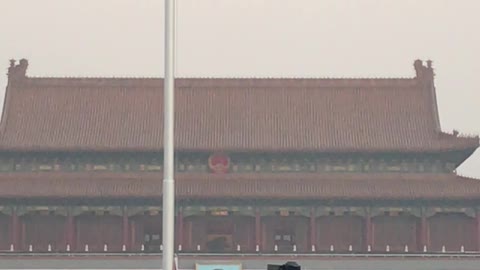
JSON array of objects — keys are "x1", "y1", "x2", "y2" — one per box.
[{"x1": 0, "y1": 173, "x2": 480, "y2": 200}]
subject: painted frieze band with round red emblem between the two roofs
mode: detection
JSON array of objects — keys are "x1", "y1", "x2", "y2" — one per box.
[{"x1": 0, "y1": 153, "x2": 455, "y2": 173}]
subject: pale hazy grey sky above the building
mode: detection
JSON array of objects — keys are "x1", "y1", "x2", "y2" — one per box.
[{"x1": 0, "y1": 0, "x2": 480, "y2": 178}]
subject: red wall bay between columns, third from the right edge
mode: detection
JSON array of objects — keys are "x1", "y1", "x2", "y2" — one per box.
[{"x1": 317, "y1": 216, "x2": 365, "y2": 251}]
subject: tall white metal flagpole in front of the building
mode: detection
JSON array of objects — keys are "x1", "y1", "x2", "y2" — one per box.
[{"x1": 162, "y1": 0, "x2": 176, "y2": 270}]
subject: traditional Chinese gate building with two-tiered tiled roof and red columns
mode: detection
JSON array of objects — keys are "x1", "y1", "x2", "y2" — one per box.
[{"x1": 0, "y1": 60, "x2": 480, "y2": 253}]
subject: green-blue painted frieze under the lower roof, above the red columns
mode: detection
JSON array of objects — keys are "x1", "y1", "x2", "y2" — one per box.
[{"x1": 0, "y1": 205, "x2": 480, "y2": 218}]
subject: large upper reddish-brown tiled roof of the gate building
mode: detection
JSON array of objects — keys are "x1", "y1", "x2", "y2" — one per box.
[{"x1": 0, "y1": 59, "x2": 479, "y2": 152}]
